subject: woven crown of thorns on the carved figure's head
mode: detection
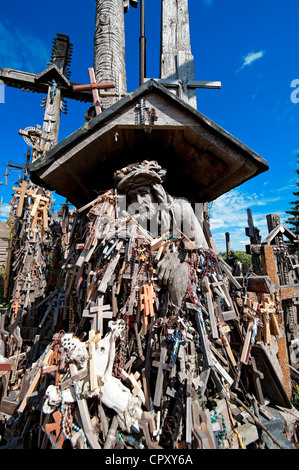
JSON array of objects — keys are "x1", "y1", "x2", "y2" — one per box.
[{"x1": 113, "y1": 160, "x2": 166, "y2": 191}]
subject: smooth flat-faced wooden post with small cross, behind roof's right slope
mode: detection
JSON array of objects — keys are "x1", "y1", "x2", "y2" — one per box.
[{"x1": 145, "y1": 0, "x2": 221, "y2": 109}]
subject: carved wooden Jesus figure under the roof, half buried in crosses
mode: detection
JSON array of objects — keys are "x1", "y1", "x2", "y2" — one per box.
[{"x1": 114, "y1": 161, "x2": 208, "y2": 307}]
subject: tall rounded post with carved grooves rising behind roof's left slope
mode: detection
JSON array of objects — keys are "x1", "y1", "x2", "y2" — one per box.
[{"x1": 93, "y1": 0, "x2": 127, "y2": 108}]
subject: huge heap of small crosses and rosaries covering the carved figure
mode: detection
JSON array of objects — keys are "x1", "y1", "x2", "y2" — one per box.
[{"x1": 0, "y1": 189, "x2": 298, "y2": 449}]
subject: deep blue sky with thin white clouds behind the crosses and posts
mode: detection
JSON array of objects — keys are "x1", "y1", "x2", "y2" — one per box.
[{"x1": 0, "y1": 0, "x2": 299, "y2": 251}]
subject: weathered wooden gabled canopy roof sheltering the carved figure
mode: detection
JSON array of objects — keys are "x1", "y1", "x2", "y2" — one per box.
[{"x1": 29, "y1": 79, "x2": 269, "y2": 207}]
